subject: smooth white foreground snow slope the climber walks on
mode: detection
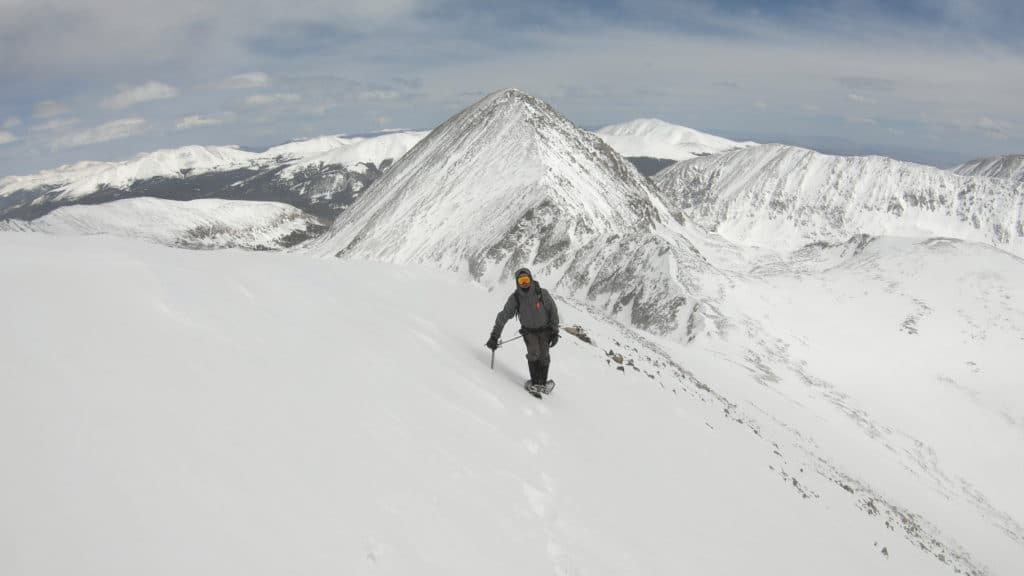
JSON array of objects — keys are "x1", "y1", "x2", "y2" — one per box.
[{"x1": 0, "y1": 233, "x2": 1022, "y2": 576}]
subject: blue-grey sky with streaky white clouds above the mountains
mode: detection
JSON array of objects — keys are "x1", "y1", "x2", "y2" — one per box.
[{"x1": 0, "y1": 0, "x2": 1024, "y2": 176}]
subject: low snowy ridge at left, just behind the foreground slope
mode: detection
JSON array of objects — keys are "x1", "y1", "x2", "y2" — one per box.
[{"x1": 0, "y1": 198, "x2": 326, "y2": 250}]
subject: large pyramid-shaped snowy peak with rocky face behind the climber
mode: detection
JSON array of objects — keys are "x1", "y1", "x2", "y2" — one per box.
[{"x1": 310, "y1": 90, "x2": 711, "y2": 331}]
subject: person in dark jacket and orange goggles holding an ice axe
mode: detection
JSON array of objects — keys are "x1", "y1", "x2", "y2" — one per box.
[{"x1": 486, "y1": 269, "x2": 558, "y2": 394}]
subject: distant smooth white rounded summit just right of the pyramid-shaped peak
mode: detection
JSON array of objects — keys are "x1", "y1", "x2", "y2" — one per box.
[{"x1": 595, "y1": 118, "x2": 756, "y2": 161}]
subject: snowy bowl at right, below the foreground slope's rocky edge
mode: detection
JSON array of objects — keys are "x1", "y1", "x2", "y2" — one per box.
[{"x1": 696, "y1": 237, "x2": 1024, "y2": 574}]
